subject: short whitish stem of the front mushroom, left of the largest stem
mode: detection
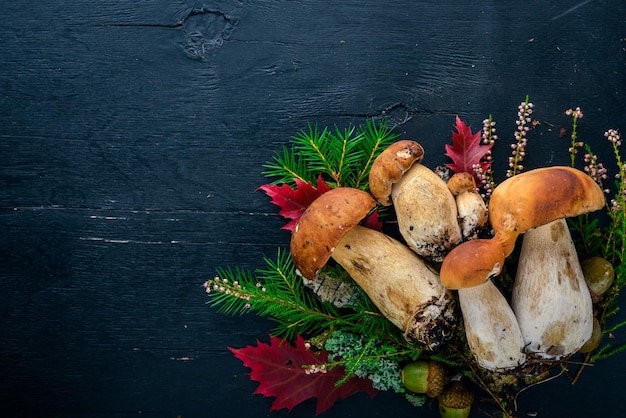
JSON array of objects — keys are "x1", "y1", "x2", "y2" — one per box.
[{"x1": 459, "y1": 280, "x2": 526, "y2": 370}]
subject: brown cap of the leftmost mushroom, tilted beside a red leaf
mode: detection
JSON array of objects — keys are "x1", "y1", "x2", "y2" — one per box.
[{"x1": 290, "y1": 187, "x2": 376, "y2": 280}]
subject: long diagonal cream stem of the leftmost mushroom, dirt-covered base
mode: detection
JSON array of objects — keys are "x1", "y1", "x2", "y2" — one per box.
[{"x1": 331, "y1": 226, "x2": 456, "y2": 348}]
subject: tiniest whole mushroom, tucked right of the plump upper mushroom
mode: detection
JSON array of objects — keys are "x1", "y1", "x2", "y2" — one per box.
[{"x1": 448, "y1": 172, "x2": 488, "y2": 239}]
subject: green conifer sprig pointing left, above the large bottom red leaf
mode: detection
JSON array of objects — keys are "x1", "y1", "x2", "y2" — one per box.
[{"x1": 204, "y1": 249, "x2": 401, "y2": 341}]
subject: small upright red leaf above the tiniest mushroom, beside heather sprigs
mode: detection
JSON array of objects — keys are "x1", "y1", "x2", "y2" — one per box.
[{"x1": 446, "y1": 116, "x2": 493, "y2": 176}]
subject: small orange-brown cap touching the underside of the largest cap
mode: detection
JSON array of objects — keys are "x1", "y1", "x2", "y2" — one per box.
[{"x1": 439, "y1": 237, "x2": 504, "y2": 290}]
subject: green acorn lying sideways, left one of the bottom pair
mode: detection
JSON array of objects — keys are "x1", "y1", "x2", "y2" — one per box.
[{"x1": 402, "y1": 360, "x2": 447, "y2": 398}]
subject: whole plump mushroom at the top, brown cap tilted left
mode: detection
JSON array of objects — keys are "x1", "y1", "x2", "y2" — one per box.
[{"x1": 369, "y1": 140, "x2": 461, "y2": 261}]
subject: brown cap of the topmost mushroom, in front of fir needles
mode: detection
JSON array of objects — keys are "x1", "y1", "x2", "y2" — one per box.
[{"x1": 369, "y1": 139, "x2": 424, "y2": 206}]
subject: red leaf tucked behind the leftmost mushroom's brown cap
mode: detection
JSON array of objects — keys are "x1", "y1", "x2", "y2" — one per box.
[{"x1": 259, "y1": 175, "x2": 330, "y2": 232}]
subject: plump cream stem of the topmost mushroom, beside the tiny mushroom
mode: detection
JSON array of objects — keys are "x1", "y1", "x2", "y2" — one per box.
[{"x1": 391, "y1": 164, "x2": 461, "y2": 261}]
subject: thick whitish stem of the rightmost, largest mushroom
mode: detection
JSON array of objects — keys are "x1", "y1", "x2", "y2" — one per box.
[{"x1": 511, "y1": 219, "x2": 593, "y2": 359}]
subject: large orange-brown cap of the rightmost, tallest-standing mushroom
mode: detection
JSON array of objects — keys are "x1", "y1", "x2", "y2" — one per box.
[{"x1": 489, "y1": 166, "x2": 605, "y2": 256}]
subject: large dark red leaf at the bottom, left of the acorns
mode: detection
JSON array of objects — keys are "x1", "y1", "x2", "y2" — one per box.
[{"x1": 228, "y1": 335, "x2": 377, "y2": 414}]
